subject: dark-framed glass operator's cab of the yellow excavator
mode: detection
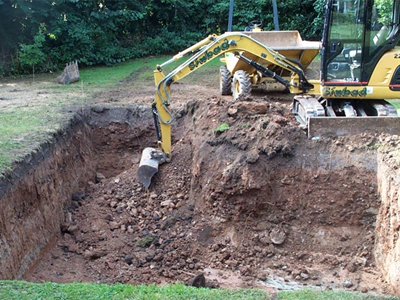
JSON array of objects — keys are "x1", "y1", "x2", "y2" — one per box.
[{"x1": 321, "y1": 0, "x2": 400, "y2": 86}]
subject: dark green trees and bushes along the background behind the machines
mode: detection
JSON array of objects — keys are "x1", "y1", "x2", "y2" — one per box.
[{"x1": 0, "y1": 0, "x2": 324, "y2": 75}]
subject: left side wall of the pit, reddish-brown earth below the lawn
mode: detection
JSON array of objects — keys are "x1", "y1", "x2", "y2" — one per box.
[{"x1": 0, "y1": 118, "x2": 95, "y2": 279}]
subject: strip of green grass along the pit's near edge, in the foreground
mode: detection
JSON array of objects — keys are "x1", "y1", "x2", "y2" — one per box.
[{"x1": 0, "y1": 281, "x2": 400, "y2": 300}]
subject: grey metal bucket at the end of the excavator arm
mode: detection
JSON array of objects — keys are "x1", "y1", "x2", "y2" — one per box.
[{"x1": 137, "y1": 147, "x2": 167, "y2": 189}]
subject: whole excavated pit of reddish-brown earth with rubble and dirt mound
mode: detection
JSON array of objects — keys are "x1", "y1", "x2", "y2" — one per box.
[{"x1": 0, "y1": 97, "x2": 399, "y2": 293}]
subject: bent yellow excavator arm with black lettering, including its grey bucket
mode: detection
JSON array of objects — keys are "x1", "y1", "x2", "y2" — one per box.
[{"x1": 138, "y1": 32, "x2": 313, "y2": 188}]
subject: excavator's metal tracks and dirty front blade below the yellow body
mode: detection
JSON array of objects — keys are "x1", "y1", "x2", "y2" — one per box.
[{"x1": 293, "y1": 95, "x2": 400, "y2": 138}]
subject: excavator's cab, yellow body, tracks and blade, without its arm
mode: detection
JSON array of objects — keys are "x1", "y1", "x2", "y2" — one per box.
[{"x1": 293, "y1": 0, "x2": 400, "y2": 138}]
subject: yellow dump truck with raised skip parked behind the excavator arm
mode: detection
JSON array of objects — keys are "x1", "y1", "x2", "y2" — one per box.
[{"x1": 220, "y1": 26, "x2": 321, "y2": 95}]
